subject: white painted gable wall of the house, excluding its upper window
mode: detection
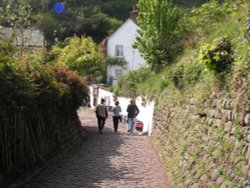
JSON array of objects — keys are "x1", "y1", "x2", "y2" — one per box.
[{"x1": 107, "y1": 19, "x2": 146, "y2": 84}]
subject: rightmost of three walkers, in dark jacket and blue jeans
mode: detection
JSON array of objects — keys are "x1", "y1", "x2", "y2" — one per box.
[{"x1": 127, "y1": 100, "x2": 140, "y2": 133}]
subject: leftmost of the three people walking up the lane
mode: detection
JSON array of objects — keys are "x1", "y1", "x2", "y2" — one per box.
[{"x1": 95, "y1": 99, "x2": 108, "y2": 133}]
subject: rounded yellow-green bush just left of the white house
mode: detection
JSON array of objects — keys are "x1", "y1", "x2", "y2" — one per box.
[{"x1": 51, "y1": 36, "x2": 106, "y2": 81}]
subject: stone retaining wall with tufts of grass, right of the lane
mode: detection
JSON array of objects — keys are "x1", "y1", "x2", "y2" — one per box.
[{"x1": 153, "y1": 98, "x2": 250, "y2": 188}]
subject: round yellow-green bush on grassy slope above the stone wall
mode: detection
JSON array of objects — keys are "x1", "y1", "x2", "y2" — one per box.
[{"x1": 198, "y1": 38, "x2": 234, "y2": 73}]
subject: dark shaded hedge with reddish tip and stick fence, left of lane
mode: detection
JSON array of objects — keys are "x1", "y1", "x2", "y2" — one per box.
[{"x1": 0, "y1": 50, "x2": 88, "y2": 176}]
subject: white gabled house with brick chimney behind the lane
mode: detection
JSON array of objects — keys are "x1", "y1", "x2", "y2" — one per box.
[{"x1": 107, "y1": 8, "x2": 146, "y2": 85}]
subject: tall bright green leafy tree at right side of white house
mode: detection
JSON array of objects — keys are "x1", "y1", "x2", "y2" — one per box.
[{"x1": 135, "y1": 0, "x2": 181, "y2": 70}]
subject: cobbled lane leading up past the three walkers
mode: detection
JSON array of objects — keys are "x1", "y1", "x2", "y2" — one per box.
[{"x1": 24, "y1": 108, "x2": 170, "y2": 188}]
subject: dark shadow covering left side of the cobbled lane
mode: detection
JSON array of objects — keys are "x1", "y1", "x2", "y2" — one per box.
[{"x1": 25, "y1": 108, "x2": 127, "y2": 188}]
